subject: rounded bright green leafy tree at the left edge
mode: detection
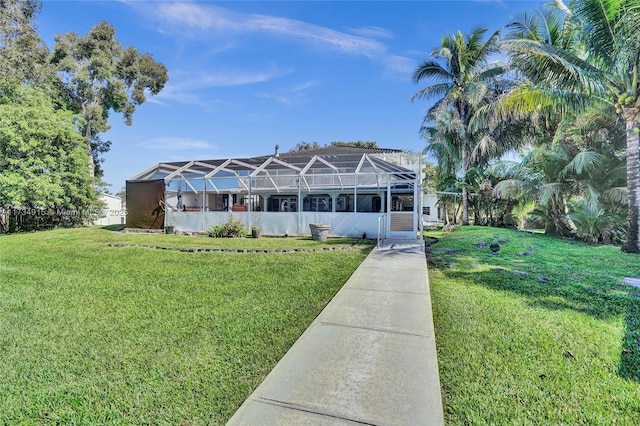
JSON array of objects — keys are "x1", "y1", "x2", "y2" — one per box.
[{"x1": 0, "y1": 88, "x2": 97, "y2": 231}]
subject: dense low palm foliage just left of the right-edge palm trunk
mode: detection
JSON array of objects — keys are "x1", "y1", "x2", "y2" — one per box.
[{"x1": 496, "y1": 102, "x2": 628, "y2": 242}]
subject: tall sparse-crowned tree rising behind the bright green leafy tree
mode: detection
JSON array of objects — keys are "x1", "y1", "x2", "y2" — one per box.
[{"x1": 51, "y1": 22, "x2": 168, "y2": 176}]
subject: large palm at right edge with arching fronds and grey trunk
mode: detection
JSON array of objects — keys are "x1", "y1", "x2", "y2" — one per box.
[{"x1": 504, "y1": 0, "x2": 640, "y2": 253}]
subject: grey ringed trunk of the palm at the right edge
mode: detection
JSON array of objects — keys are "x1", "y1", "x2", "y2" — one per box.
[{"x1": 623, "y1": 115, "x2": 640, "y2": 253}]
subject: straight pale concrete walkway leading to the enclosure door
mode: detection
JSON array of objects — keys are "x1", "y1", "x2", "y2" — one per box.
[{"x1": 228, "y1": 241, "x2": 444, "y2": 425}]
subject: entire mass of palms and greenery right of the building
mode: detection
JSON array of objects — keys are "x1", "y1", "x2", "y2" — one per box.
[{"x1": 412, "y1": 0, "x2": 640, "y2": 252}]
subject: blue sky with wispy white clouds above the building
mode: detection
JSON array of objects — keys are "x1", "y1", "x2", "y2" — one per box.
[{"x1": 37, "y1": 0, "x2": 543, "y2": 192}]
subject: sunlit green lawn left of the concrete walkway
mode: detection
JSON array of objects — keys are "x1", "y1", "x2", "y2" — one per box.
[{"x1": 0, "y1": 228, "x2": 372, "y2": 425}]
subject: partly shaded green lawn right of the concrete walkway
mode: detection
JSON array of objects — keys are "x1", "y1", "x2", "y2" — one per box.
[{"x1": 427, "y1": 227, "x2": 640, "y2": 425}]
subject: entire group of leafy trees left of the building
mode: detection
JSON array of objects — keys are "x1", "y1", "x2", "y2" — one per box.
[{"x1": 0, "y1": 0, "x2": 168, "y2": 231}]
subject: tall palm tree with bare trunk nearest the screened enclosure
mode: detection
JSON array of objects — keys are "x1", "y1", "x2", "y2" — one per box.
[{"x1": 410, "y1": 28, "x2": 505, "y2": 225}]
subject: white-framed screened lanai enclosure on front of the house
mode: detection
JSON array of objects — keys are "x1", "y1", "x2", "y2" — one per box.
[{"x1": 127, "y1": 147, "x2": 422, "y2": 238}]
